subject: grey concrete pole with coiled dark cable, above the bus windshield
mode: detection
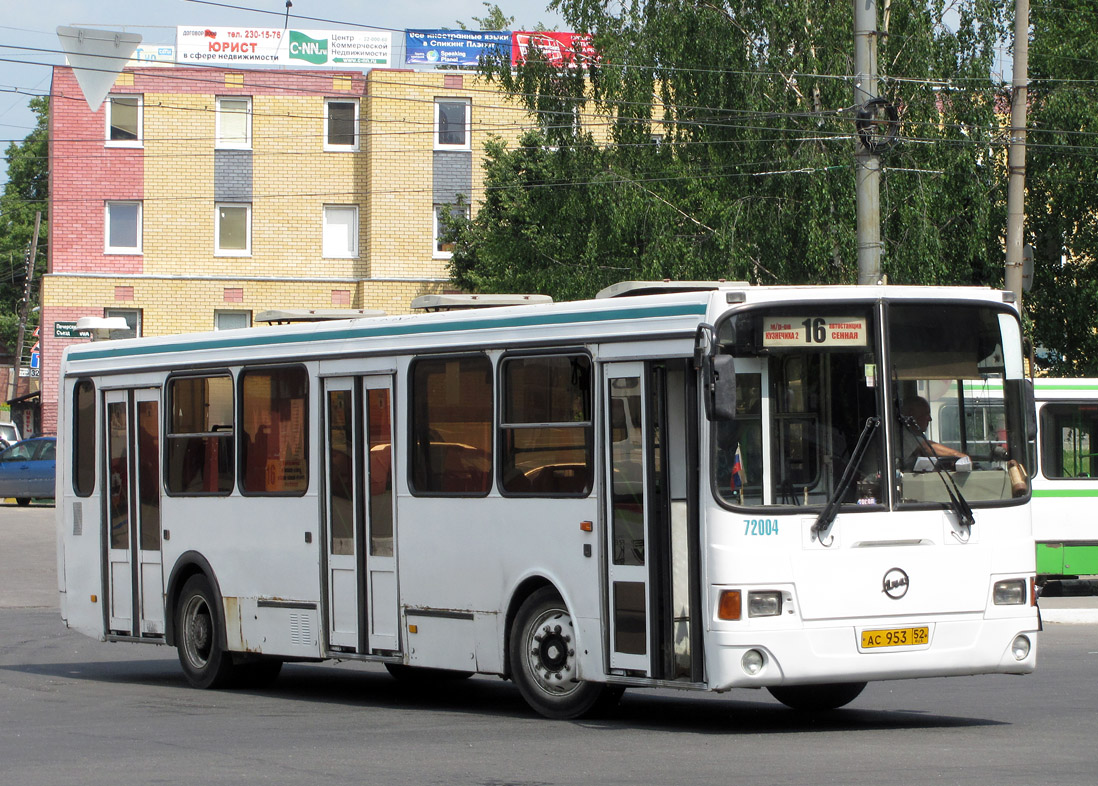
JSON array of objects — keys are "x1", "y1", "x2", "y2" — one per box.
[{"x1": 854, "y1": 0, "x2": 881, "y2": 284}]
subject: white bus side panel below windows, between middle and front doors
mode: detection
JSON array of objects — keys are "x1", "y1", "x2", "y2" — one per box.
[{"x1": 397, "y1": 498, "x2": 603, "y2": 674}]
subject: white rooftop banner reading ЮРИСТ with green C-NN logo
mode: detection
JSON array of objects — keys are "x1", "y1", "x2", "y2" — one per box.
[{"x1": 176, "y1": 27, "x2": 392, "y2": 68}]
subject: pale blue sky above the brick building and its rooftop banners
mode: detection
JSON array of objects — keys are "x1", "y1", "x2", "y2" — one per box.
[{"x1": 0, "y1": 0, "x2": 567, "y2": 177}]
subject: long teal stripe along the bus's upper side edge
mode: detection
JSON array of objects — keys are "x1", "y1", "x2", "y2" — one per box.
[{"x1": 69, "y1": 303, "x2": 706, "y2": 361}]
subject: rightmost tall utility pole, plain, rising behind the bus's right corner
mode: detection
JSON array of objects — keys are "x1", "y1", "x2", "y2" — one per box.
[{"x1": 1005, "y1": 0, "x2": 1029, "y2": 310}]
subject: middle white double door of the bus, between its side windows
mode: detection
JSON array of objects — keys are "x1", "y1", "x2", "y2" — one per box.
[{"x1": 324, "y1": 374, "x2": 400, "y2": 653}]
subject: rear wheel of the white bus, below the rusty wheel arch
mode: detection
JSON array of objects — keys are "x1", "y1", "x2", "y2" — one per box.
[{"x1": 176, "y1": 573, "x2": 236, "y2": 688}]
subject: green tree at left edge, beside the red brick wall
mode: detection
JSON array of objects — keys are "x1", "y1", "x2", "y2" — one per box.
[{"x1": 0, "y1": 97, "x2": 49, "y2": 351}]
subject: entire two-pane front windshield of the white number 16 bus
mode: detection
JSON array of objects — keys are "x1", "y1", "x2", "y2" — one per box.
[{"x1": 712, "y1": 302, "x2": 1028, "y2": 510}]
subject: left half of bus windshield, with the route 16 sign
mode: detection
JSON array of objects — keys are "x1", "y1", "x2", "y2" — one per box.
[{"x1": 712, "y1": 304, "x2": 885, "y2": 507}]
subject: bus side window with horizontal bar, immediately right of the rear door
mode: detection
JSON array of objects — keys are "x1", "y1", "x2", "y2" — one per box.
[{"x1": 165, "y1": 374, "x2": 234, "y2": 495}]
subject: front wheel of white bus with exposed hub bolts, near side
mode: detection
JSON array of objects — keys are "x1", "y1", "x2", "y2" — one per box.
[{"x1": 508, "y1": 587, "x2": 620, "y2": 720}]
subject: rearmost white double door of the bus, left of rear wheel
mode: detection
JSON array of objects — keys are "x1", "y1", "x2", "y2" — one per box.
[{"x1": 103, "y1": 389, "x2": 165, "y2": 638}]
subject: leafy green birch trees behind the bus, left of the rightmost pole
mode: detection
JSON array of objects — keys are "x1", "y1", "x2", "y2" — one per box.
[{"x1": 451, "y1": 0, "x2": 1005, "y2": 297}]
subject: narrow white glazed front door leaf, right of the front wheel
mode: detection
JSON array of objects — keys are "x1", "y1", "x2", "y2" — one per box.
[{"x1": 603, "y1": 362, "x2": 651, "y2": 676}]
